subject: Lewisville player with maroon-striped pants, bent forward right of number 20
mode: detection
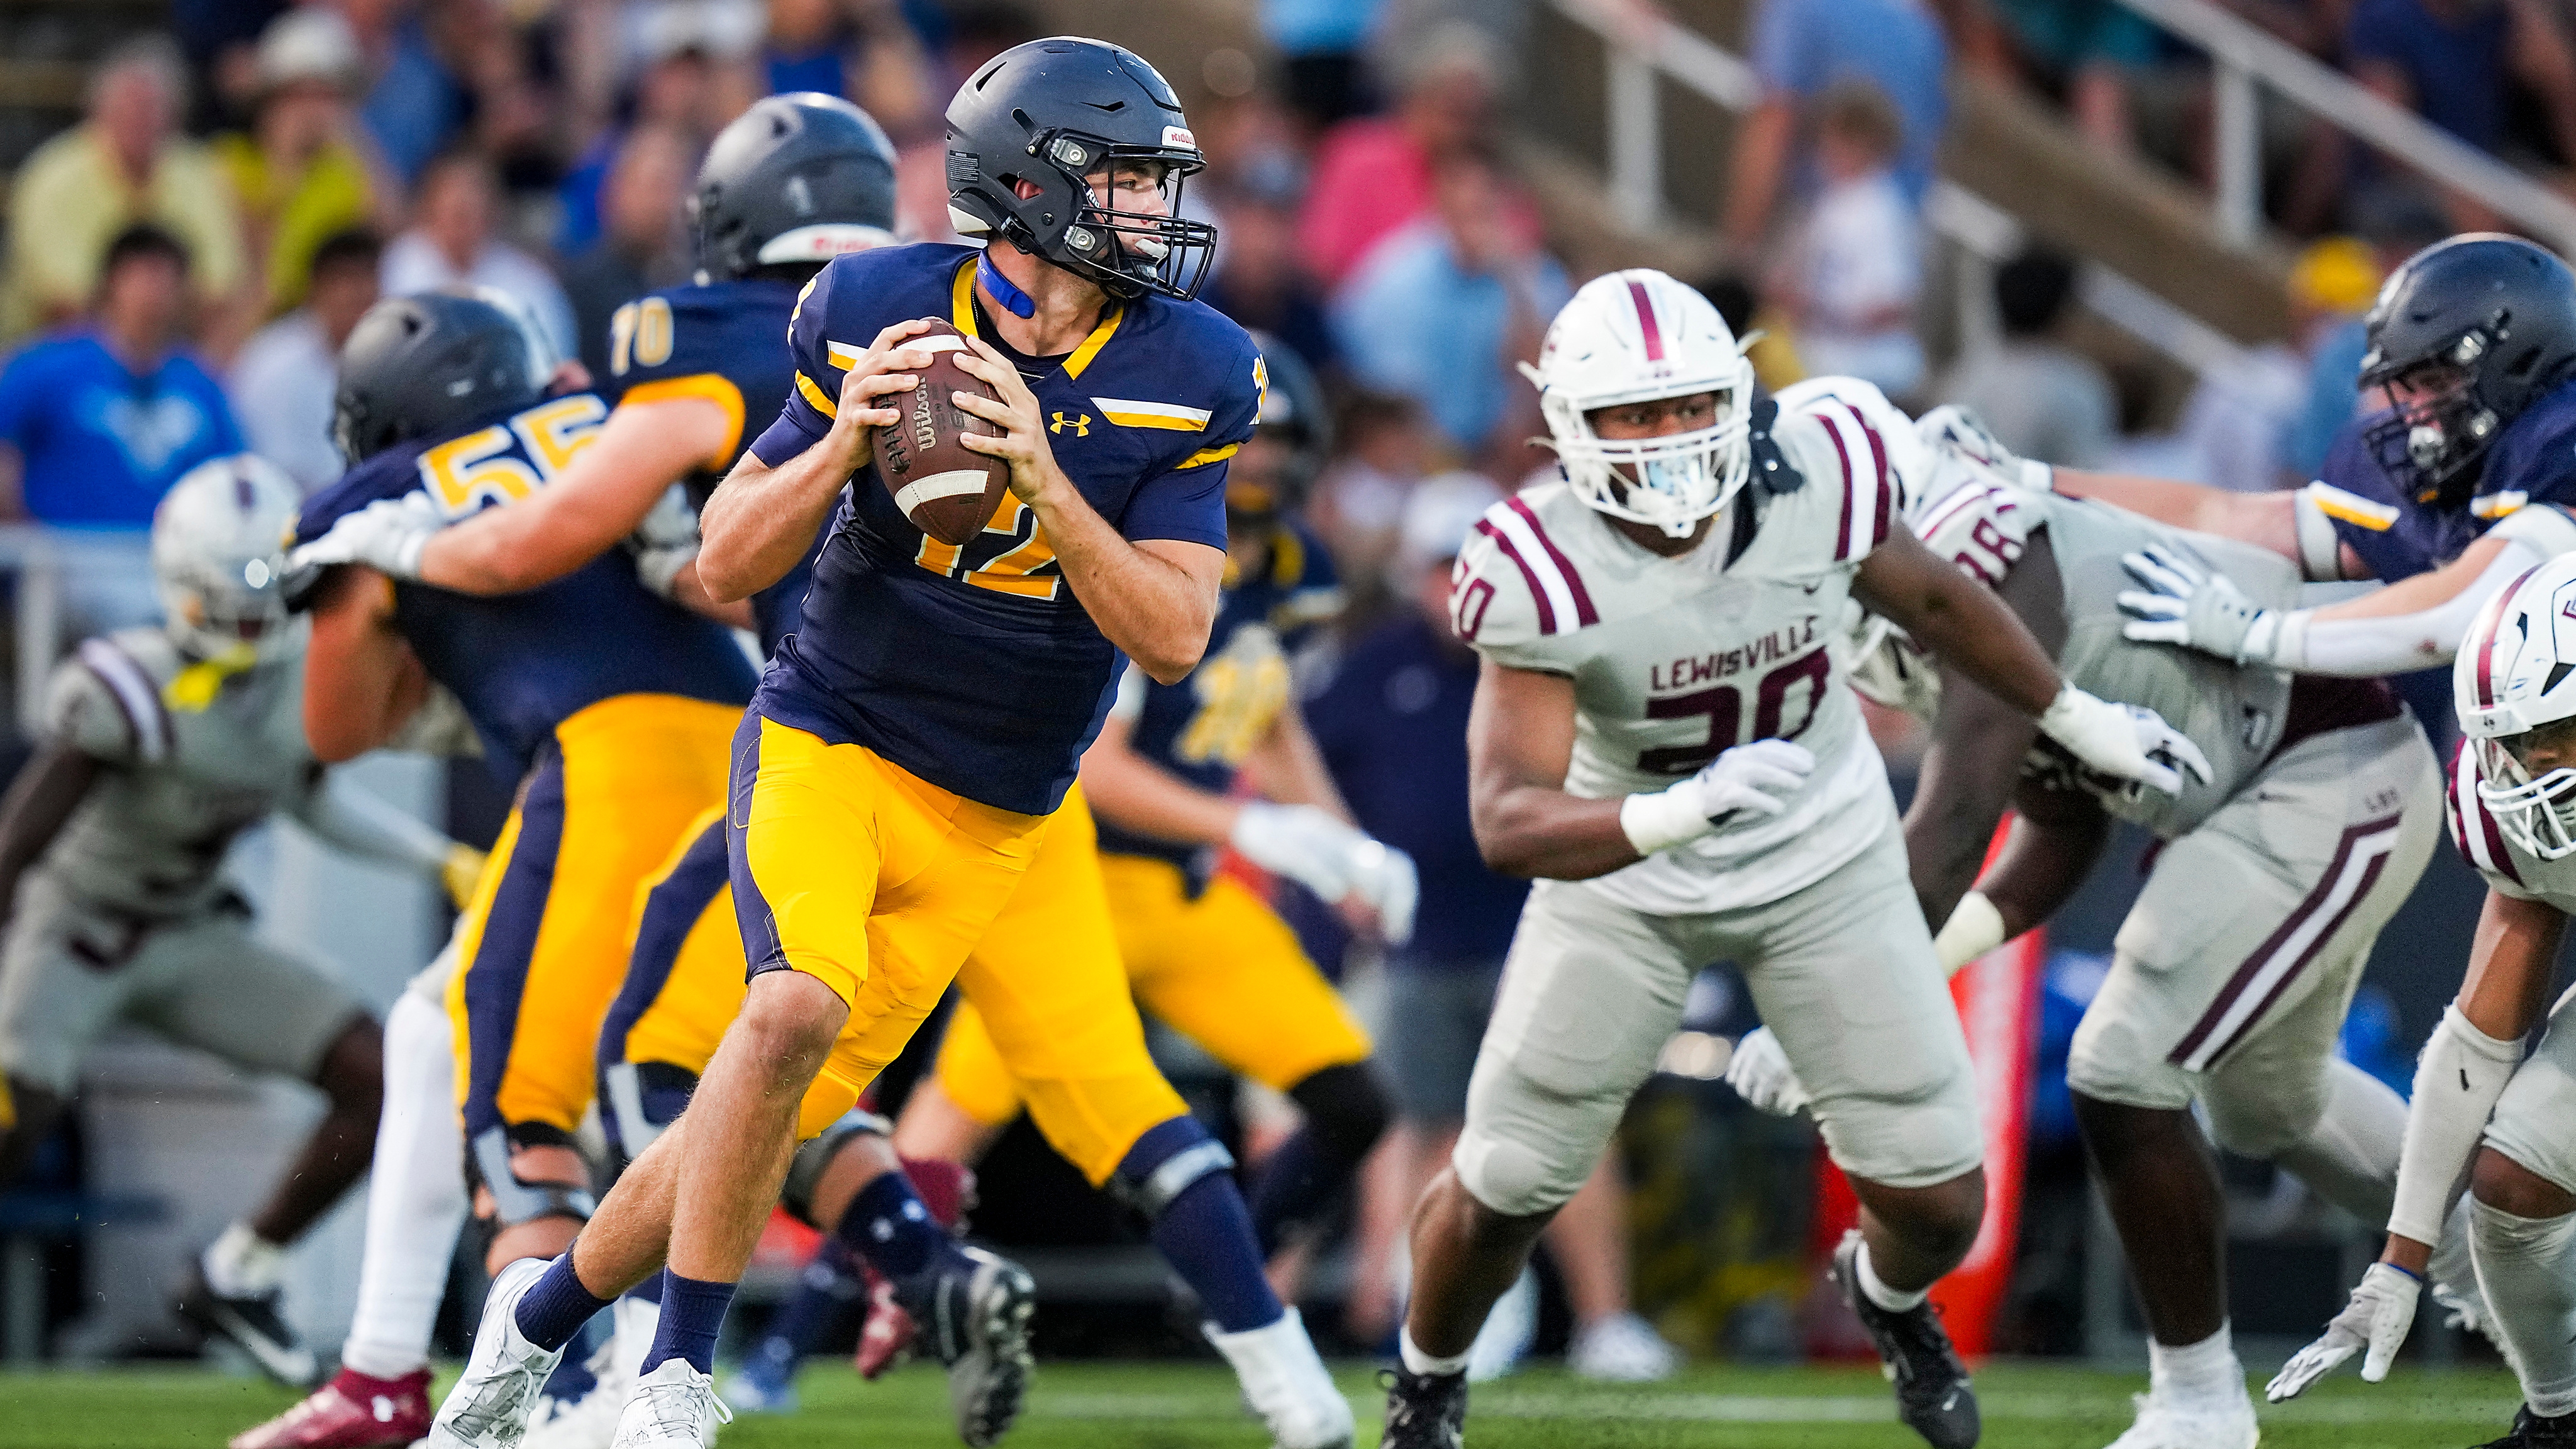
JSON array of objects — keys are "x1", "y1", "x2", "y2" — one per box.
[{"x1": 1728, "y1": 402, "x2": 2475, "y2": 1449}]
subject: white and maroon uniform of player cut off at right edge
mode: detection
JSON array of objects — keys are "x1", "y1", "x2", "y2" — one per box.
[{"x1": 2450, "y1": 747, "x2": 2576, "y2": 1191}]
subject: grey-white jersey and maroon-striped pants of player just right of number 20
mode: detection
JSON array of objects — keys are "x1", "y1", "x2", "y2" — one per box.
[{"x1": 1916, "y1": 480, "x2": 2442, "y2": 1129}]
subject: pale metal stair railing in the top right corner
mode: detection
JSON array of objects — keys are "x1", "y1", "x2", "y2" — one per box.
[{"x1": 2120, "y1": 0, "x2": 2576, "y2": 255}]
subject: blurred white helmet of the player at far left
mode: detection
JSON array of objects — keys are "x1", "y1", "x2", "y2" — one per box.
[{"x1": 152, "y1": 454, "x2": 304, "y2": 660}]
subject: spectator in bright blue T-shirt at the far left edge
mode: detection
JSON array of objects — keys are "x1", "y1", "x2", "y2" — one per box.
[{"x1": 0, "y1": 225, "x2": 242, "y2": 626}]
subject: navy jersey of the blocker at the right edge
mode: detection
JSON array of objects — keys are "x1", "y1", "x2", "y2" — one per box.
[{"x1": 2308, "y1": 382, "x2": 2576, "y2": 583}]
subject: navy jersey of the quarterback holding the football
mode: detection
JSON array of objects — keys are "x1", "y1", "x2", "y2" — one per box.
[{"x1": 752, "y1": 242, "x2": 1260, "y2": 814}]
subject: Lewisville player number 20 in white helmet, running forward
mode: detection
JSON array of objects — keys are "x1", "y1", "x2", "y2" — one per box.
[{"x1": 1386, "y1": 270, "x2": 2207, "y2": 1449}]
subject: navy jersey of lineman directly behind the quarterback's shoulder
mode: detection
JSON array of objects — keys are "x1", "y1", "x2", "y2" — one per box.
[{"x1": 600, "y1": 279, "x2": 822, "y2": 655}]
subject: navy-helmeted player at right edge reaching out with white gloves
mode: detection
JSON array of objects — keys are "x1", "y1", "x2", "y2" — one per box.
[{"x1": 1950, "y1": 235, "x2": 2576, "y2": 678}]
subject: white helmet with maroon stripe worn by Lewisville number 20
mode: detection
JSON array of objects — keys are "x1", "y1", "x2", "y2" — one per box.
[{"x1": 1520, "y1": 268, "x2": 1754, "y2": 539}]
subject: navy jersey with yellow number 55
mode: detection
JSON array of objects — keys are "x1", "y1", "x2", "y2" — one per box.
[{"x1": 296, "y1": 392, "x2": 752, "y2": 781}]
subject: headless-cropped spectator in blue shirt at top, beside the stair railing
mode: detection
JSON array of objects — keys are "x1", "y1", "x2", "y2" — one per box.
[{"x1": 1726, "y1": 0, "x2": 1950, "y2": 253}]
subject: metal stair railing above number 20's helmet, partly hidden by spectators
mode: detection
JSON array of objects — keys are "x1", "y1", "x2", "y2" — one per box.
[{"x1": 1553, "y1": 0, "x2": 2244, "y2": 377}]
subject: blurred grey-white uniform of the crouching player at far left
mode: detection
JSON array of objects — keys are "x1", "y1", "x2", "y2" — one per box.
[{"x1": 0, "y1": 629, "x2": 366, "y2": 1093}]
